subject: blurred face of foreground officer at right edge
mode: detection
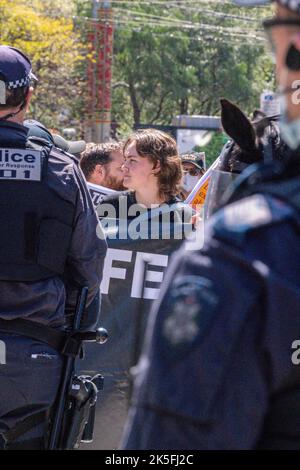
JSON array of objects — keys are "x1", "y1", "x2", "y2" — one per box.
[{"x1": 269, "y1": 5, "x2": 300, "y2": 119}]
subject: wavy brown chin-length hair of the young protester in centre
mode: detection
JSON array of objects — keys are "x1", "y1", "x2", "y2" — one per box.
[{"x1": 123, "y1": 129, "x2": 182, "y2": 201}]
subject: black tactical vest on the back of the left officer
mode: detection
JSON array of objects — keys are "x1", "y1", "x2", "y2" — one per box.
[{"x1": 0, "y1": 146, "x2": 75, "y2": 282}]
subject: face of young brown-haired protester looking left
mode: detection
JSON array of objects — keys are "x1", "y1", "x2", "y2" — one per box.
[{"x1": 123, "y1": 142, "x2": 156, "y2": 191}]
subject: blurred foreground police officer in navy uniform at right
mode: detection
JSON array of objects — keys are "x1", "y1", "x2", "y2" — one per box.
[{"x1": 123, "y1": 0, "x2": 300, "y2": 449}]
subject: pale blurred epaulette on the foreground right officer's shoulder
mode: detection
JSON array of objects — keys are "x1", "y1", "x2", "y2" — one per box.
[{"x1": 211, "y1": 194, "x2": 293, "y2": 246}]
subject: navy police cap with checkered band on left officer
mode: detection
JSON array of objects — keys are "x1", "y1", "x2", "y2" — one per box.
[{"x1": 0, "y1": 46, "x2": 37, "y2": 89}]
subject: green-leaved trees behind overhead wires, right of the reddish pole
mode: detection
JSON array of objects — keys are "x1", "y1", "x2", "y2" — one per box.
[{"x1": 109, "y1": 1, "x2": 273, "y2": 135}]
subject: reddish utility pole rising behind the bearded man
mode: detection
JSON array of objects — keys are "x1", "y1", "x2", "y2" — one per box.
[{"x1": 85, "y1": 0, "x2": 113, "y2": 143}]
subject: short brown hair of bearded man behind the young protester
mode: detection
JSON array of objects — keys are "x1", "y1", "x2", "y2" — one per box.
[{"x1": 80, "y1": 142, "x2": 123, "y2": 179}]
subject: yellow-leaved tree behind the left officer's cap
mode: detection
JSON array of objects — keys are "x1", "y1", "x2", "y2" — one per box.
[{"x1": 0, "y1": 0, "x2": 85, "y2": 128}]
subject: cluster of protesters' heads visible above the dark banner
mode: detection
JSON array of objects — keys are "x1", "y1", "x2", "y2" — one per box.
[{"x1": 80, "y1": 129, "x2": 205, "y2": 208}]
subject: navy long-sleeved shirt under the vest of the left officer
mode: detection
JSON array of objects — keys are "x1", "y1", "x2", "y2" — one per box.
[{"x1": 0, "y1": 122, "x2": 106, "y2": 325}]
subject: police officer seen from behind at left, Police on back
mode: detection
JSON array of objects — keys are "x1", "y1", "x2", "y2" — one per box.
[{"x1": 0, "y1": 46, "x2": 106, "y2": 449}]
